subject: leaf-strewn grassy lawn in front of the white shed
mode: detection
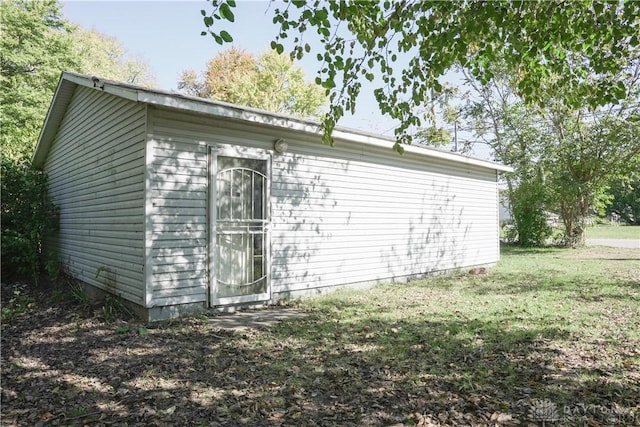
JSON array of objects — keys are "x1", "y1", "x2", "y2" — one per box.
[{"x1": 2, "y1": 247, "x2": 640, "y2": 426}]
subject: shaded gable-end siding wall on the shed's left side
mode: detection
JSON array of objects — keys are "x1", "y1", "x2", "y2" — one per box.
[{"x1": 44, "y1": 87, "x2": 146, "y2": 304}]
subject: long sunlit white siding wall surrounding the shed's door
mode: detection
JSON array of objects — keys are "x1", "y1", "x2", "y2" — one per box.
[{"x1": 147, "y1": 109, "x2": 499, "y2": 305}]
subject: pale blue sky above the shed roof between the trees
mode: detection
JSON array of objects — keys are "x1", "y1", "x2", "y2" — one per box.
[{"x1": 62, "y1": 0, "x2": 395, "y2": 136}]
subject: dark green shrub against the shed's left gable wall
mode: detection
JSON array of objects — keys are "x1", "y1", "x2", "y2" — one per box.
[{"x1": 0, "y1": 156, "x2": 58, "y2": 282}]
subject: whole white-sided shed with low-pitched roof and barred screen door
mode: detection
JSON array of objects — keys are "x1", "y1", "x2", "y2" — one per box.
[{"x1": 33, "y1": 73, "x2": 510, "y2": 320}]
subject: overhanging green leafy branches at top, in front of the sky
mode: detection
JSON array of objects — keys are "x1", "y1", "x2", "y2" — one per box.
[{"x1": 202, "y1": 0, "x2": 640, "y2": 151}]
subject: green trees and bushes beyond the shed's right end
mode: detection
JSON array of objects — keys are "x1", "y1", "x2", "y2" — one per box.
[{"x1": 456, "y1": 61, "x2": 640, "y2": 246}]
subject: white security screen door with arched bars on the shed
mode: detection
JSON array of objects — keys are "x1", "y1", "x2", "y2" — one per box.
[{"x1": 211, "y1": 152, "x2": 271, "y2": 305}]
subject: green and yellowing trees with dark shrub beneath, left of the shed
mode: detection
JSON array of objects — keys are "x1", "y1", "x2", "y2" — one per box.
[{"x1": 0, "y1": 0, "x2": 158, "y2": 281}]
